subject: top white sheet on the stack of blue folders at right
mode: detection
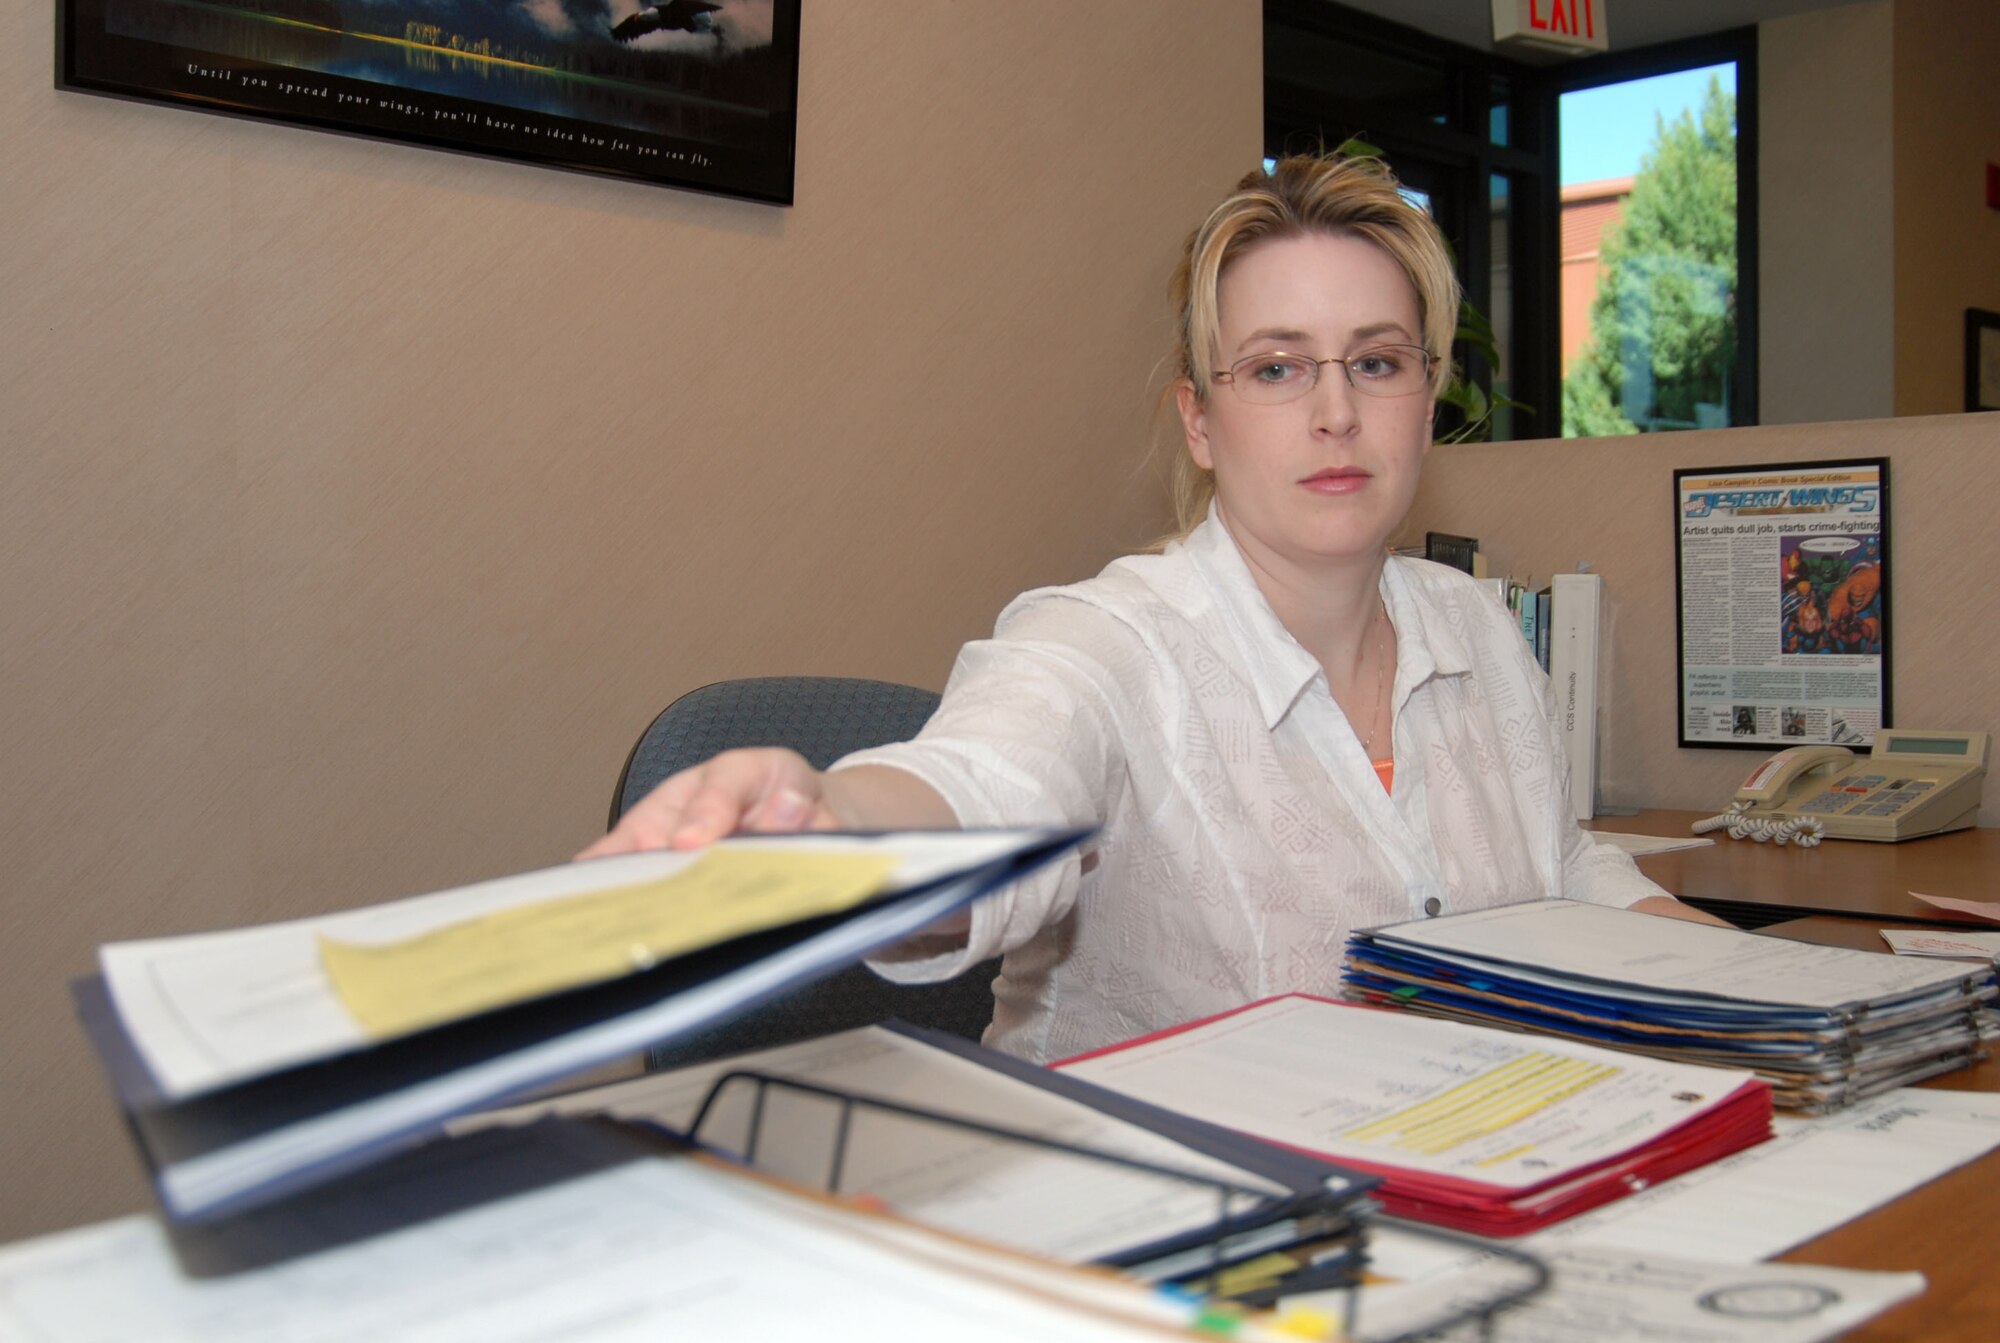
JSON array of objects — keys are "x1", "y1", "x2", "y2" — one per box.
[{"x1": 1378, "y1": 899, "x2": 1966, "y2": 1009}]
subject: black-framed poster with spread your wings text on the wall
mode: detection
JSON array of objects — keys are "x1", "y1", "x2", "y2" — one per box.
[{"x1": 56, "y1": 0, "x2": 802, "y2": 204}]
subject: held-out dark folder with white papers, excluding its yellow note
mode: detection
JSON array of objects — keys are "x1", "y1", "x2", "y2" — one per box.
[{"x1": 76, "y1": 831, "x2": 1082, "y2": 1217}]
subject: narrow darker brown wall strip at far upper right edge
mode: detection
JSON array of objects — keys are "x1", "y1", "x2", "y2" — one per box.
[{"x1": 1894, "y1": 0, "x2": 2000, "y2": 416}]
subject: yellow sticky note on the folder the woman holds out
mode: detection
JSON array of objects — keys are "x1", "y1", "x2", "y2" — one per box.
[{"x1": 320, "y1": 847, "x2": 896, "y2": 1039}]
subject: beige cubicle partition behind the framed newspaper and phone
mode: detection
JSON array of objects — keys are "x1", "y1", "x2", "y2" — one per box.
[{"x1": 1406, "y1": 414, "x2": 2000, "y2": 825}]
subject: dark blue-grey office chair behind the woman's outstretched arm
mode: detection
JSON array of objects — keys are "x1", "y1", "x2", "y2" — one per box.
[{"x1": 610, "y1": 675, "x2": 1000, "y2": 1069}]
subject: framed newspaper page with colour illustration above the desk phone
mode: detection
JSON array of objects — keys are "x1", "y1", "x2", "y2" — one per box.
[{"x1": 1674, "y1": 458, "x2": 1892, "y2": 751}]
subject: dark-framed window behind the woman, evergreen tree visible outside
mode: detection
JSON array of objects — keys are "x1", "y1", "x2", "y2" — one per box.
[{"x1": 1264, "y1": 0, "x2": 1756, "y2": 438}]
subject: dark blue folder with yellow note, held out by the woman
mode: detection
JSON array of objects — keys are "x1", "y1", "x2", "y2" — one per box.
[{"x1": 72, "y1": 829, "x2": 1088, "y2": 1219}]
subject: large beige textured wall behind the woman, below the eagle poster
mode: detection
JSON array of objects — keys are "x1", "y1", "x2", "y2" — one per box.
[{"x1": 0, "y1": 0, "x2": 1262, "y2": 1239}]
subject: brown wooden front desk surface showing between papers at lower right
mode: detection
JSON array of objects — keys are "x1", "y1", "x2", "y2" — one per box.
[{"x1": 1768, "y1": 919, "x2": 2000, "y2": 1343}]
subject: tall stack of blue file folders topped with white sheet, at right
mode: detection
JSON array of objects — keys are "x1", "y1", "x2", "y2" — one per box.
[{"x1": 1342, "y1": 899, "x2": 1996, "y2": 1113}]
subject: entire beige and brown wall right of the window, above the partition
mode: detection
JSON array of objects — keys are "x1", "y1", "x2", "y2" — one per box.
[{"x1": 1758, "y1": 0, "x2": 2000, "y2": 424}]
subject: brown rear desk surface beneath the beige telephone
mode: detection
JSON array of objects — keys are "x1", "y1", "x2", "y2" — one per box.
[{"x1": 1588, "y1": 811, "x2": 2000, "y2": 929}]
